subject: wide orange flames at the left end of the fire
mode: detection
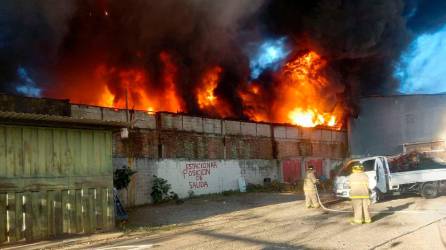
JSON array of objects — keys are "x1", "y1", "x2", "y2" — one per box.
[{"x1": 59, "y1": 52, "x2": 184, "y2": 112}]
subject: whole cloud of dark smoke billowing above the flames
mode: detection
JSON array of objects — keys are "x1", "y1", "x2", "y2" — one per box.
[{"x1": 0, "y1": 0, "x2": 446, "y2": 117}]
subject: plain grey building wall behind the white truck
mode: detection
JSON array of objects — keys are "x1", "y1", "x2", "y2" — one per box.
[{"x1": 348, "y1": 94, "x2": 446, "y2": 157}]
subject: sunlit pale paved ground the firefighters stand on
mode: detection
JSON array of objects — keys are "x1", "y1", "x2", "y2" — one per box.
[{"x1": 7, "y1": 193, "x2": 446, "y2": 250}]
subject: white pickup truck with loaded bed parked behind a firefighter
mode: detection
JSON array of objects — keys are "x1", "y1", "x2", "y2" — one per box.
[{"x1": 334, "y1": 156, "x2": 446, "y2": 202}]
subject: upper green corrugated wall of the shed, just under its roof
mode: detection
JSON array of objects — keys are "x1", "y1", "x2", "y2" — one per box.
[{"x1": 0, "y1": 126, "x2": 112, "y2": 178}]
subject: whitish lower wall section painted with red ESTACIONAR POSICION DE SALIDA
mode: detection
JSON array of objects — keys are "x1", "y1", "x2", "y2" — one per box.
[{"x1": 113, "y1": 157, "x2": 280, "y2": 206}]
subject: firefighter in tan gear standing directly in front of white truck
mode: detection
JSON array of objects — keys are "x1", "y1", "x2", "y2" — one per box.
[{"x1": 348, "y1": 163, "x2": 372, "y2": 224}]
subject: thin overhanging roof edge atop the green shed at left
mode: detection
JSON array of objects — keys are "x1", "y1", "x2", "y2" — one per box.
[{"x1": 0, "y1": 111, "x2": 128, "y2": 127}]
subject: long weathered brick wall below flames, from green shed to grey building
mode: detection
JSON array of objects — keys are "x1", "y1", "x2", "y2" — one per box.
[{"x1": 110, "y1": 113, "x2": 347, "y2": 206}]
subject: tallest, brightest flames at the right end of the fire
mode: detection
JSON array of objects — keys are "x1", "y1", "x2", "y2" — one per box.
[{"x1": 240, "y1": 51, "x2": 343, "y2": 128}]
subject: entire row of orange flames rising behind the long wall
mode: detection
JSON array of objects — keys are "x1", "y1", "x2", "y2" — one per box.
[{"x1": 48, "y1": 51, "x2": 343, "y2": 128}]
